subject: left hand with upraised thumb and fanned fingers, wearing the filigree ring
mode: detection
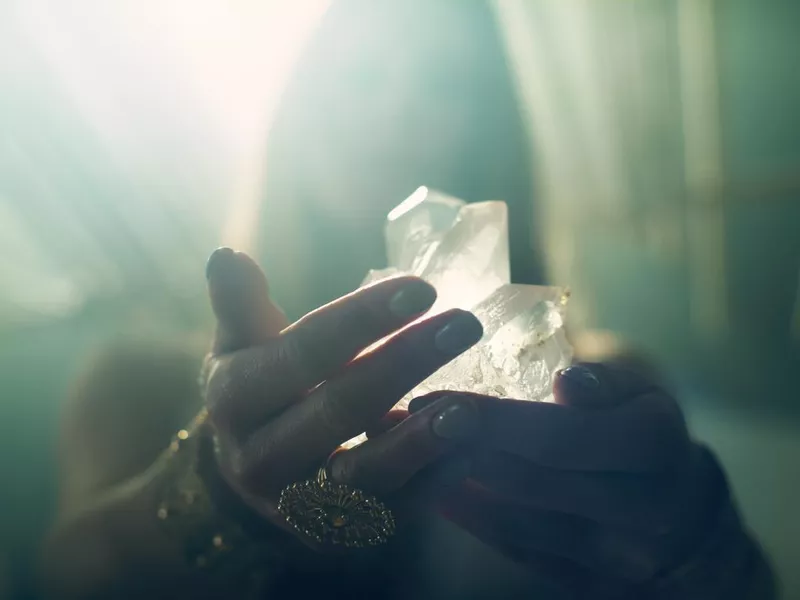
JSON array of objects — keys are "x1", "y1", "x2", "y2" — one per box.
[{"x1": 200, "y1": 249, "x2": 482, "y2": 545}]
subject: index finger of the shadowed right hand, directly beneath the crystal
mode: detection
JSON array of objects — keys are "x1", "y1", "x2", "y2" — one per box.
[{"x1": 412, "y1": 392, "x2": 691, "y2": 473}]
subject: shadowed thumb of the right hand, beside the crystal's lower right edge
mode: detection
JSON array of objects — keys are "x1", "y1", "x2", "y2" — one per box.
[{"x1": 553, "y1": 363, "x2": 657, "y2": 408}]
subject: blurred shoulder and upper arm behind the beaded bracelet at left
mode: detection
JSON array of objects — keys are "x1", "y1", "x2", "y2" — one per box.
[{"x1": 58, "y1": 341, "x2": 201, "y2": 513}]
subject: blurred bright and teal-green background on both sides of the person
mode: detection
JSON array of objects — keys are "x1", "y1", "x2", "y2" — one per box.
[{"x1": 0, "y1": 0, "x2": 800, "y2": 598}]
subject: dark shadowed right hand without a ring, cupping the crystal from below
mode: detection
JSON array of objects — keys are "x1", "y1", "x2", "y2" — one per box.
[{"x1": 410, "y1": 364, "x2": 725, "y2": 598}]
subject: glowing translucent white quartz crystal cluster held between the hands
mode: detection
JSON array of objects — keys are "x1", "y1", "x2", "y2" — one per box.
[{"x1": 364, "y1": 187, "x2": 572, "y2": 408}]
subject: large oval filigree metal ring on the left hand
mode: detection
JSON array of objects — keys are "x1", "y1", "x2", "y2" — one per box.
[{"x1": 278, "y1": 466, "x2": 395, "y2": 548}]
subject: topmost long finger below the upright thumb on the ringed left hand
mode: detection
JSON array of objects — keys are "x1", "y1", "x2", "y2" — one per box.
[{"x1": 207, "y1": 277, "x2": 436, "y2": 432}]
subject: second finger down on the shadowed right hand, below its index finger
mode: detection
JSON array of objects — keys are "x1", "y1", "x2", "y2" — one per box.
[{"x1": 469, "y1": 451, "x2": 686, "y2": 534}]
